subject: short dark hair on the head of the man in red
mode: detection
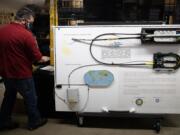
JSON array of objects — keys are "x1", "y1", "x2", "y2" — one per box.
[{"x1": 15, "y1": 7, "x2": 35, "y2": 20}]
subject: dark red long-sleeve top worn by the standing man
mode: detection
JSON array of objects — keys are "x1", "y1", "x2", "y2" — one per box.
[{"x1": 0, "y1": 23, "x2": 42, "y2": 79}]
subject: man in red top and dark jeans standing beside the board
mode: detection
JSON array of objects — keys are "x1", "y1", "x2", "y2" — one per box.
[{"x1": 0, "y1": 7, "x2": 49, "y2": 130}]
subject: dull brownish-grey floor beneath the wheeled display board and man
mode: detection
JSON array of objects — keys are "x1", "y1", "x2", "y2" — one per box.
[{"x1": 0, "y1": 84, "x2": 180, "y2": 135}]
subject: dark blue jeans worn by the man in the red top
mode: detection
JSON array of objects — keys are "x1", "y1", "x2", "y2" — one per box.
[{"x1": 0, "y1": 78, "x2": 41, "y2": 126}]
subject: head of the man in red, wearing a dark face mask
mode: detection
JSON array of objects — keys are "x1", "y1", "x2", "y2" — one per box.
[{"x1": 15, "y1": 7, "x2": 35, "y2": 29}]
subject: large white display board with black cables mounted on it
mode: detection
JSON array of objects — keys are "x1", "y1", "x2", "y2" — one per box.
[{"x1": 54, "y1": 25, "x2": 180, "y2": 114}]
